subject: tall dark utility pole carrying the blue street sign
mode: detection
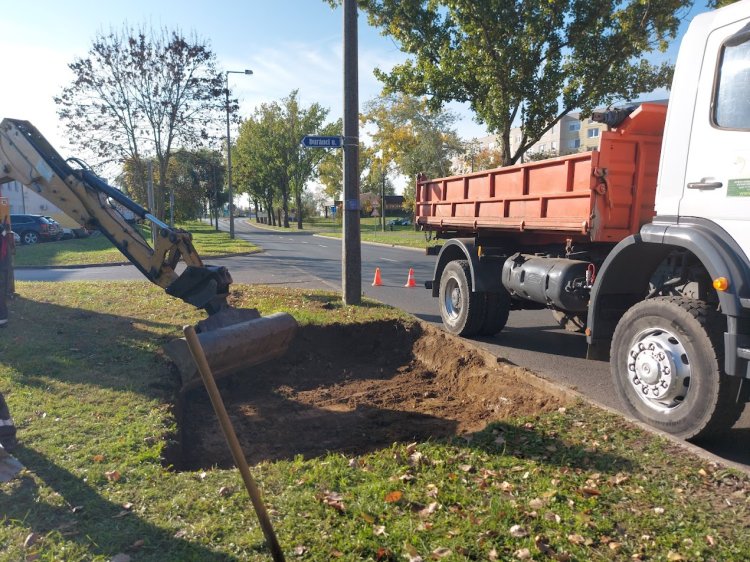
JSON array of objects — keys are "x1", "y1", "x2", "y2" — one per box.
[{"x1": 341, "y1": 0, "x2": 362, "y2": 304}]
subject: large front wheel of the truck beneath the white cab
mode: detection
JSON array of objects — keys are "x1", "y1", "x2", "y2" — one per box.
[{"x1": 610, "y1": 296, "x2": 750, "y2": 439}]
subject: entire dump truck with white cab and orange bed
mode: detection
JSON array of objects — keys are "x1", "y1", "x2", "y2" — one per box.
[{"x1": 415, "y1": 1, "x2": 750, "y2": 439}]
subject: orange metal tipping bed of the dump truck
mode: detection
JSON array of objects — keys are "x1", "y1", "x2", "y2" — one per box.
[{"x1": 415, "y1": 104, "x2": 667, "y2": 242}]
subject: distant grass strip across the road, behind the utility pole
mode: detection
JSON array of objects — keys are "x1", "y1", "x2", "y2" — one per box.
[{"x1": 253, "y1": 217, "x2": 442, "y2": 248}]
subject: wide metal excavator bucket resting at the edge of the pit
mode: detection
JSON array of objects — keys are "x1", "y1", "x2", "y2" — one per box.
[{"x1": 164, "y1": 308, "x2": 297, "y2": 391}]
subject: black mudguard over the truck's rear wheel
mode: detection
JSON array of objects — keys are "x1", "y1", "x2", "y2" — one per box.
[{"x1": 428, "y1": 238, "x2": 503, "y2": 297}]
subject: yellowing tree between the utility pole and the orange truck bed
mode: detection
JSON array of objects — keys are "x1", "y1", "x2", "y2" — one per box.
[{"x1": 362, "y1": 93, "x2": 462, "y2": 212}]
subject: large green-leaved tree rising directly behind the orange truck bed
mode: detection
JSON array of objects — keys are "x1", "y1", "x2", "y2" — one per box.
[{"x1": 360, "y1": 0, "x2": 696, "y2": 165}]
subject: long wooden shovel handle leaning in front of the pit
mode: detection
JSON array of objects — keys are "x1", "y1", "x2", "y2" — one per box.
[{"x1": 182, "y1": 326, "x2": 284, "y2": 562}]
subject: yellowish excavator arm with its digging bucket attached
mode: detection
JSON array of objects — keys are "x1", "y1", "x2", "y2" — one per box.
[{"x1": 0, "y1": 119, "x2": 297, "y2": 390}]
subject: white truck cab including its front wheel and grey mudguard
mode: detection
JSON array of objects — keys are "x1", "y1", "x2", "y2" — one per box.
[{"x1": 587, "y1": 1, "x2": 750, "y2": 438}]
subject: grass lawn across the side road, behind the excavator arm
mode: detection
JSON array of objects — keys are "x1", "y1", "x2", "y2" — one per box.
[{"x1": 15, "y1": 221, "x2": 257, "y2": 267}]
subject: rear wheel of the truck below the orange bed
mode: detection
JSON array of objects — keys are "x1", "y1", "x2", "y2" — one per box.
[{"x1": 439, "y1": 260, "x2": 486, "y2": 337}]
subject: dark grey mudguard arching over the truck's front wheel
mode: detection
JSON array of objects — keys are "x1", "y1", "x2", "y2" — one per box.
[{"x1": 587, "y1": 217, "x2": 750, "y2": 375}]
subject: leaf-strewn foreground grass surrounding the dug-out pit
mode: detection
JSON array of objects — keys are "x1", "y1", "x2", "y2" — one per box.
[{"x1": 0, "y1": 282, "x2": 750, "y2": 562}]
